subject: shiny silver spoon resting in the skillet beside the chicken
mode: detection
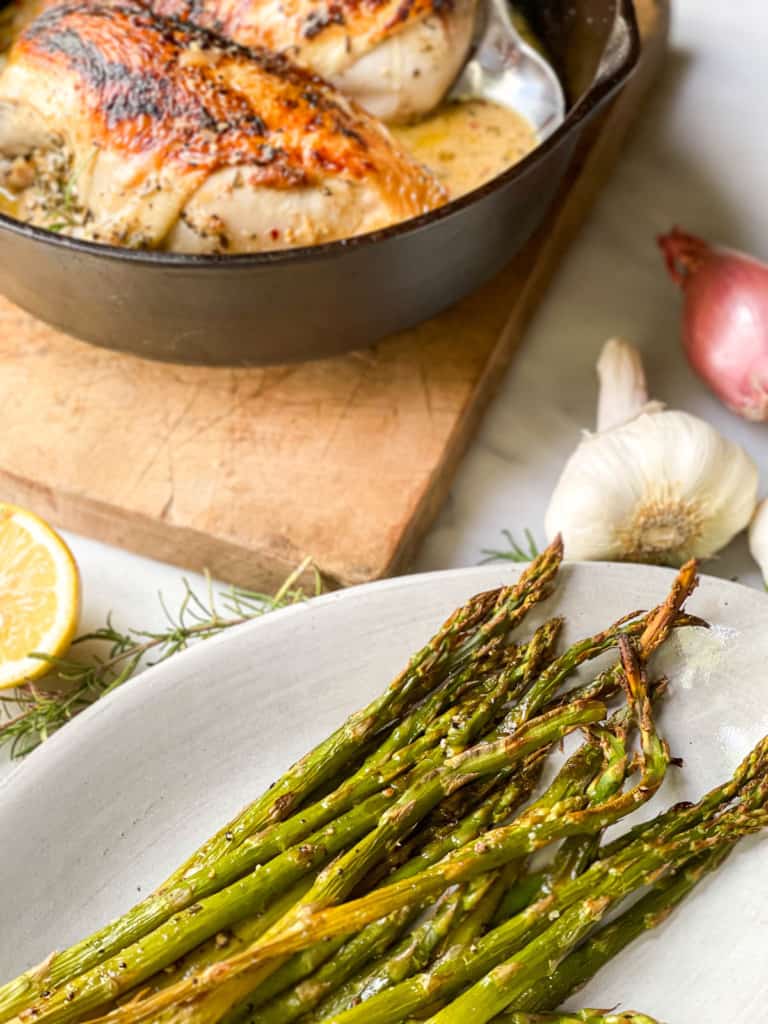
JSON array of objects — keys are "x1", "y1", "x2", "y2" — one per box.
[{"x1": 447, "y1": 0, "x2": 565, "y2": 142}]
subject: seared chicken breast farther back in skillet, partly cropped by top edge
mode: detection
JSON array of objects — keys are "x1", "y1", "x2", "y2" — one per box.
[{"x1": 146, "y1": 0, "x2": 476, "y2": 122}]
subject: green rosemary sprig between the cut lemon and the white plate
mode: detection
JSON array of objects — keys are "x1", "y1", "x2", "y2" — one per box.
[{"x1": 0, "y1": 558, "x2": 323, "y2": 758}]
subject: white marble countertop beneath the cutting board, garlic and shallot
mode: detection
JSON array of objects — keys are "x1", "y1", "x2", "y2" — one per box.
[{"x1": 0, "y1": 0, "x2": 768, "y2": 774}]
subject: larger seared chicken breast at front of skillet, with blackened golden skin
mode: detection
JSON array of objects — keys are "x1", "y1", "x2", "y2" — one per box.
[{"x1": 0, "y1": 2, "x2": 445, "y2": 253}]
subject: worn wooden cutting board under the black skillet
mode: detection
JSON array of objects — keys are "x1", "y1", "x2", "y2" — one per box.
[{"x1": 0, "y1": 0, "x2": 669, "y2": 587}]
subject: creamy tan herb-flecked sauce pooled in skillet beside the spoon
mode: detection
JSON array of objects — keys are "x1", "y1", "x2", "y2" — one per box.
[{"x1": 391, "y1": 99, "x2": 538, "y2": 199}]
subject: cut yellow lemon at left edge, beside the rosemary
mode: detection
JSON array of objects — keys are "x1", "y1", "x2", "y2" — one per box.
[{"x1": 0, "y1": 502, "x2": 80, "y2": 689}]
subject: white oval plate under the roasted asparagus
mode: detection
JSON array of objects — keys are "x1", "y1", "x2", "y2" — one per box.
[{"x1": 0, "y1": 564, "x2": 768, "y2": 1024}]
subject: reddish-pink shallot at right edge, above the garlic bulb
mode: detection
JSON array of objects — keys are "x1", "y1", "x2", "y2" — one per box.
[{"x1": 658, "y1": 228, "x2": 768, "y2": 421}]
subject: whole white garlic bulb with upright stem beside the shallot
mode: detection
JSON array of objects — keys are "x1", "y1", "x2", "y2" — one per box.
[{"x1": 545, "y1": 340, "x2": 758, "y2": 565}]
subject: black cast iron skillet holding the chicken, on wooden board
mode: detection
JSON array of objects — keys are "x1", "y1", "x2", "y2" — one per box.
[{"x1": 0, "y1": 0, "x2": 639, "y2": 365}]
